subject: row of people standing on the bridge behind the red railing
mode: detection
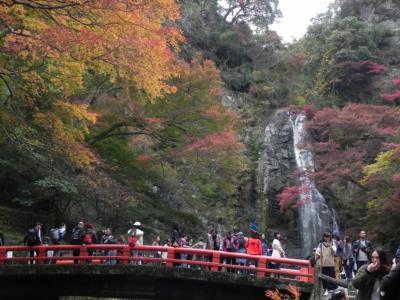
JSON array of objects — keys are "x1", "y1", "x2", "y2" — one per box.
[{"x1": 2, "y1": 221, "x2": 285, "y2": 272}]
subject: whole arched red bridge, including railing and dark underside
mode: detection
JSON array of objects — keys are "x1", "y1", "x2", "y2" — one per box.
[{"x1": 0, "y1": 244, "x2": 314, "y2": 299}]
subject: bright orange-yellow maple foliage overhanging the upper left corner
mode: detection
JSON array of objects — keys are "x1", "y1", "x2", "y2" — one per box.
[{"x1": 0, "y1": 0, "x2": 184, "y2": 177}]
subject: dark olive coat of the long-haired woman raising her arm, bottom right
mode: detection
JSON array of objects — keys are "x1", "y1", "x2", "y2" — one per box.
[{"x1": 353, "y1": 265, "x2": 394, "y2": 300}]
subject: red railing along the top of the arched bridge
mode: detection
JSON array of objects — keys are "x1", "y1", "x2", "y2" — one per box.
[{"x1": 0, "y1": 244, "x2": 314, "y2": 283}]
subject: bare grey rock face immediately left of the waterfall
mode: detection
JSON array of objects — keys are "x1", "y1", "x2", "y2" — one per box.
[{"x1": 257, "y1": 109, "x2": 302, "y2": 257}]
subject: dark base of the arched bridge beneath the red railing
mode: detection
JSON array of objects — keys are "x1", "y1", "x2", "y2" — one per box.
[{"x1": 0, "y1": 264, "x2": 312, "y2": 300}]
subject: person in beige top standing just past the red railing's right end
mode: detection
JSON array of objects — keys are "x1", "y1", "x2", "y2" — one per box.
[{"x1": 315, "y1": 232, "x2": 337, "y2": 296}]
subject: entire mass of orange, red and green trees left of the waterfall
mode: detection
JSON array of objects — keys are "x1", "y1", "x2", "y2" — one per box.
[{"x1": 0, "y1": 0, "x2": 245, "y2": 229}]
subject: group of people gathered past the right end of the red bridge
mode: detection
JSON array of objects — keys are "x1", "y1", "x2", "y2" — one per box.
[{"x1": 311, "y1": 230, "x2": 400, "y2": 300}]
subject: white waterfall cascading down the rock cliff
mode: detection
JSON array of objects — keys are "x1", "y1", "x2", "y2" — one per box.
[{"x1": 290, "y1": 113, "x2": 338, "y2": 254}]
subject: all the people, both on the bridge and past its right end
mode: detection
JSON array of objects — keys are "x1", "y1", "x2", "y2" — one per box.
[{"x1": 0, "y1": 221, "x2": 400, "y2": 300}]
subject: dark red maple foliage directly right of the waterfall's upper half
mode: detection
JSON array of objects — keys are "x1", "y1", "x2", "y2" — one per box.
[{"x1": 307, "y1": 104, "x2": 400, "y2": 186}]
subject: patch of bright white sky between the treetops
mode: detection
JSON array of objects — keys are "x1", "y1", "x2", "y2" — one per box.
[{"x1": 270, "y1": 0, "x2": 333, "y2": 43}]
